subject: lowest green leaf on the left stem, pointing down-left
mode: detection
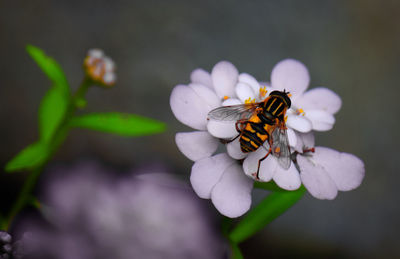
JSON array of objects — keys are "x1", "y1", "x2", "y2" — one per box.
[{"x1": 5, "y1": 142, "x2": 50, "y2": 172}]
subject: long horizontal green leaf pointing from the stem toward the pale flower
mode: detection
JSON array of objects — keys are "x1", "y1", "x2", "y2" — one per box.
[{"x1": 70, "y1": 112, "x2": 165, "y2": 136}]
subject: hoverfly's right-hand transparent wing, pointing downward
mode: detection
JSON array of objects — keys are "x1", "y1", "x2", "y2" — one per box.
[{"x1": 271, "y1": 124, "x2": 291, "y2": 169}]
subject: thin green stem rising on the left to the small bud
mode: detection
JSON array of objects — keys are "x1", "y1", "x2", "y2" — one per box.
[{"x1": 1, "y1": 77, "x2": 91, "y2": 230}]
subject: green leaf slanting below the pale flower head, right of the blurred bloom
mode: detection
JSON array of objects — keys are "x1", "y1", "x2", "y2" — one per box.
[{"x1": 229, "y1": 186, "x2": 305, "y2": 243}]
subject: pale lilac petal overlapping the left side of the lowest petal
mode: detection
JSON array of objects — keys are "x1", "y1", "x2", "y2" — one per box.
[{"x1": 190, "y1": 153, "x2": 235, "y2": 199}]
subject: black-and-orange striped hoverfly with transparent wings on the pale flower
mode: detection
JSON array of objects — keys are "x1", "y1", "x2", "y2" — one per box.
[{"x1": 208, "y1": 90, "x2": 291, "y2": 179}]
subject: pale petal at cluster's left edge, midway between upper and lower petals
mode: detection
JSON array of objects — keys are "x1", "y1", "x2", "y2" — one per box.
[{"x1": 175, "y1": 131, "x2": 219, "y2": 161}]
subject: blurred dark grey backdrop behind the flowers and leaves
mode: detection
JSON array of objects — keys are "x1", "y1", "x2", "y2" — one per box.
[{"x1": 0, "y1": 0, "x2": 400, "y2": 258}]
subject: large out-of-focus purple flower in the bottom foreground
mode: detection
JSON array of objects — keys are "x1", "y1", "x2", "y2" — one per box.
[{"x1": 15, "y1": 164, "x2": 225, "y2": 259}]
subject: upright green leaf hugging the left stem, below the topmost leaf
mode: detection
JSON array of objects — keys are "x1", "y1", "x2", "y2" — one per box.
[{"x1": 39, "y1": 87, "x2": 69, "y2": 142}]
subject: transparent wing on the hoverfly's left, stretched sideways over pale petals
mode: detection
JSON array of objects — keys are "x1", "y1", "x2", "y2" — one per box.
[{"x1": 208, "y1": 103, "x2": 258, "y2": 121}]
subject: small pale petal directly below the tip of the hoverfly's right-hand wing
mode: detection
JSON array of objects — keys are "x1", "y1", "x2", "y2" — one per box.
[{"x1": 273, "y1": 163, "x2": 301, "y2": 191}]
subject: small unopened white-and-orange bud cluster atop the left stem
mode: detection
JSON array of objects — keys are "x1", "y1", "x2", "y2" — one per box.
[{"x1": 83, "y1": 49, "x2": 116, "y2": 87}]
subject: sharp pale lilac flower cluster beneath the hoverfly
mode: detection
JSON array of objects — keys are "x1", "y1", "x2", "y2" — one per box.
[{"x1": 170, "y1": 59, "x2": 365, "y2": 217}]
